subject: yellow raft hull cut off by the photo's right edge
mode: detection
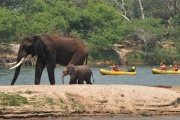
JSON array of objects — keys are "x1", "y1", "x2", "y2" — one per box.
[{"x1": 152, "y1": 68, "x2": 180, "y2": 74}]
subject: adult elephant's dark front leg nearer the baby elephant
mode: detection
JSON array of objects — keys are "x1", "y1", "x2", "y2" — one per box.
[{"x1": 46, "y1": 63, "x2": 55, "y2": 85}]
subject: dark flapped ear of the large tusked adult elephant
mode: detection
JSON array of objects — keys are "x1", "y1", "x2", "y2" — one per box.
[{"x1": 33, "y1": 35, "x2": 46, "y2": 59}]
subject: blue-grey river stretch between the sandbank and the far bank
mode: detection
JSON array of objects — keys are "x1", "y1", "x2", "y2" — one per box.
[{"x1": 0, "y1": 66, "x2": 180, "y2": 86}]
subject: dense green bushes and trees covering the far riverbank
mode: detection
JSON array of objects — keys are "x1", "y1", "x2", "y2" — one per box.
[{"x1": 0, "y1": 0, "x2": 180, "y2": 64}]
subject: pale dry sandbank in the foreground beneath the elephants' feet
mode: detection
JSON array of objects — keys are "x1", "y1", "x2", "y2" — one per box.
[{"x1": 0, "y1": 85, "x2": 180, "y2": 118}]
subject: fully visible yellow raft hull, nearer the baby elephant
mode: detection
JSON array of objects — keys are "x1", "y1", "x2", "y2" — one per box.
[{"x1": 99, "y1": 69, "x2": 136, "y2": 75}]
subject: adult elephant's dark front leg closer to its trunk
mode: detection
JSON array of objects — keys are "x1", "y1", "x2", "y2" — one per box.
[{"x1": 35, "y1": 58, "x2": 45, "y2": 85}]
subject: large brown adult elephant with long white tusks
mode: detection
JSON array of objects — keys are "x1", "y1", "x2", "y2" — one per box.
[{"x1": 10, "y1": 34, "x2": 88, "y2": 85}]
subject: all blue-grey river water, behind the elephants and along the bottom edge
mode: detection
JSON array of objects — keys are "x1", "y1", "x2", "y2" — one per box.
[{"x1": 0, "y1": 66, "x2": 180, "y2": 120}]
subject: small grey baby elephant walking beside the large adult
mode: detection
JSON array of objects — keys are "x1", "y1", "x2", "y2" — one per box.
[{"x1": 62, "y1": 65, "x2": 94, "y2": 84}]
